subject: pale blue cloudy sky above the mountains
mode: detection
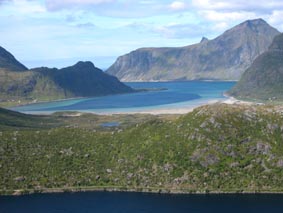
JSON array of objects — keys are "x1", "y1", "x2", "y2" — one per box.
[{"x1": 0, "y1": 0, "x2": 283, "y2": 69}]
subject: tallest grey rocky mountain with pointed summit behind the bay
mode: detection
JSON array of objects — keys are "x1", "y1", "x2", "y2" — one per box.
[{"x1": 107, "y1": 19, "x2": 279, "y2": 81}]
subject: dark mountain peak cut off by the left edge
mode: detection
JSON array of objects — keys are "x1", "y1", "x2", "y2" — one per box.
[{"x1": 0, "y1": 47, "x2": 27, "y2": 71}]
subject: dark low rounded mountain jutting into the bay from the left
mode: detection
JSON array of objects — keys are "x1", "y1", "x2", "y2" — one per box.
[{"x1": 32, "y1": 62, "x2": 133, "y2": 98}]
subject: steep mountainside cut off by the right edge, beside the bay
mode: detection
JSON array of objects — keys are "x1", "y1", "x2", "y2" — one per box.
[{"x1": 229, "y1": 34, "x2": 283, "y2": 101}]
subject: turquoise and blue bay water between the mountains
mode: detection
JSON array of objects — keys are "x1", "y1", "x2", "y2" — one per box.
[{"x1": 11, "y1": 81, "x2": 235, "y2": 114}]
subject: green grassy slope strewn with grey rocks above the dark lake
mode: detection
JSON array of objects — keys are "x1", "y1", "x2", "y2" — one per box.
[{"x1": 0, "y1": 105, "x2": 283, "y2": 193}]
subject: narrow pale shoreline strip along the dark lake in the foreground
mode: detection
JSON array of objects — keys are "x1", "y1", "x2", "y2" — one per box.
[{"x1": 3, "y1": 186, "x2": 283, "y2": 196}]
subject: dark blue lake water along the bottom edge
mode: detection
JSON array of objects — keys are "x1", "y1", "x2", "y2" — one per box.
[{"x1": 0, "y1": 192, "x2": 283, "y2": 213}]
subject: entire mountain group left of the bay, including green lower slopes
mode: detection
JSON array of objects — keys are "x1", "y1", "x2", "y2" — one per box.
[{"x1": 0, "y1": 47, "x2": 134, "y2": 103}]
